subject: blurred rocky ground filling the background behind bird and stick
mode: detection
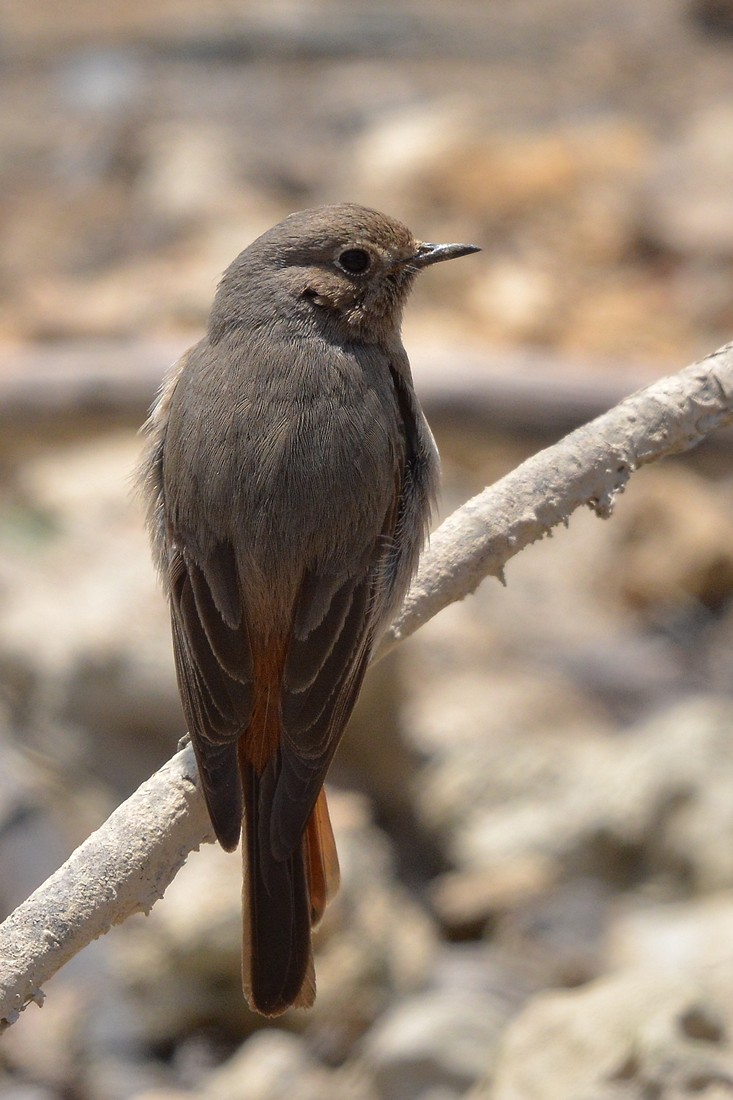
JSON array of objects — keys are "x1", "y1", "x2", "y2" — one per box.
[{"x1": 0, "y1": 0, "x2": 733, "y2": 1100}]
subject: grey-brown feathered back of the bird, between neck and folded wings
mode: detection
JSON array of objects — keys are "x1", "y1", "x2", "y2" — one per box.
[{"x1": 162, "y1": 332, "x2": 405, "y2": 629}]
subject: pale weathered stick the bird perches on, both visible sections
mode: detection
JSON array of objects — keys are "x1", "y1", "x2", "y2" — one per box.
[{"x1": 0, "y1": 344, "x2": 733, "y2": 1026}]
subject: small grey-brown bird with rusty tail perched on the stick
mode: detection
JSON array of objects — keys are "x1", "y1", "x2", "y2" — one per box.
[{"x1": 141, "y1": 204, "x2": 479, "y2": 1016}]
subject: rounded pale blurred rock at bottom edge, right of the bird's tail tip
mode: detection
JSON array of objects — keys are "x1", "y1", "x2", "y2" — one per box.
[{"x1": 362, "y1": 991, "x2": 504, "y2": 1100}]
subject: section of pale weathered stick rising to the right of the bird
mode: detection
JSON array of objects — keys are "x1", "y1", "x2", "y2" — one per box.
[{"x1": 376, "y1": 343, "x2": 733, "y2": 657}]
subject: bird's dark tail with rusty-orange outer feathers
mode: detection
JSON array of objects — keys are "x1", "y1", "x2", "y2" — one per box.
[{"x1": 240, "y1": 761, "x2": 339, "y2": 1016}]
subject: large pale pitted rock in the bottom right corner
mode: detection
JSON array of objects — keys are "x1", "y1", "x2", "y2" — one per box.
[{"x1": 470, "y1": 971, "x2": 733, "y2": 1100}]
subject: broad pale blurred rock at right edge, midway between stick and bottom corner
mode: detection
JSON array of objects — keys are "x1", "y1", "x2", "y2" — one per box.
[{"x1": 420, "y1": 699, "x2": 733, "y2": 889}]
